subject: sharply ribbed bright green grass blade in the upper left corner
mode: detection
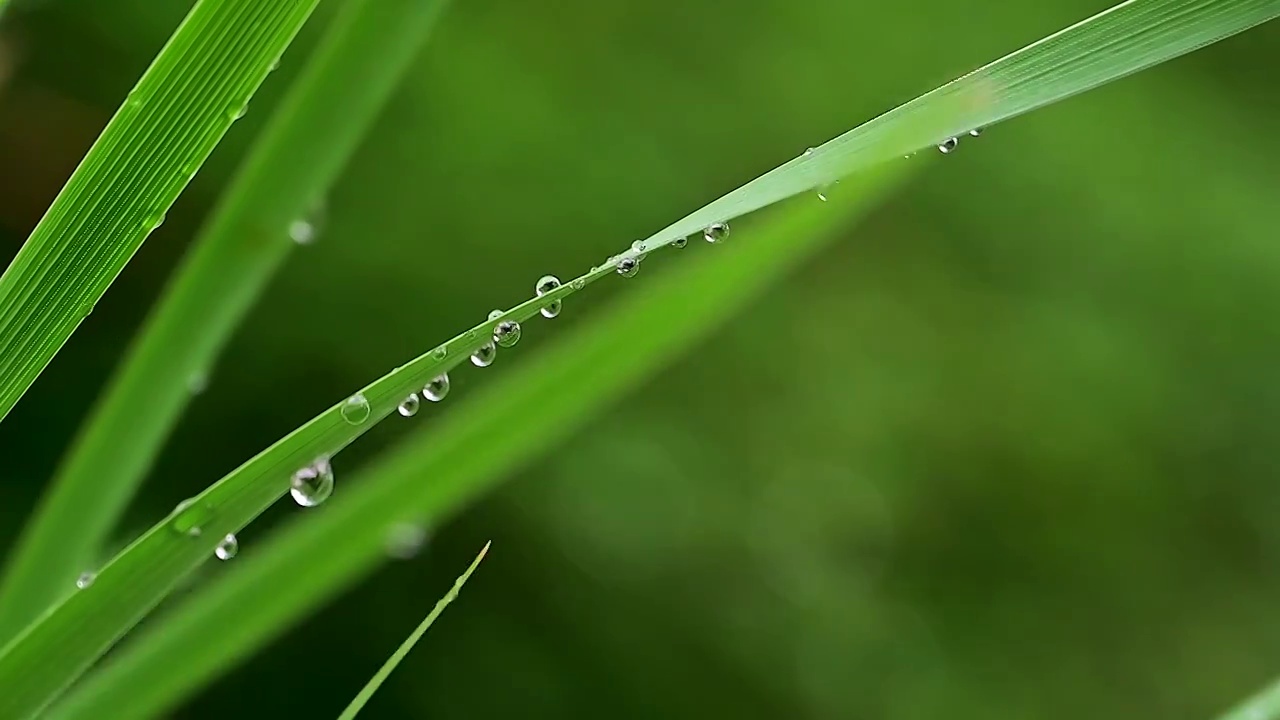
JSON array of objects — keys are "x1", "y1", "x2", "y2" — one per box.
[{"x1": 0, "y1": 0, "x2": 316, "y2": 419}]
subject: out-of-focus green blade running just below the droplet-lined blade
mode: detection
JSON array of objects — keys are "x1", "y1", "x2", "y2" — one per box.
[{"x1": 49, "y1": 162, "x2": 911, "y2": 720}]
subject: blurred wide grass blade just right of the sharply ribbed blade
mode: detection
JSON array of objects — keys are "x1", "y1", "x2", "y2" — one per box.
[{"x1": 0, "y1": 0, "x2": 455, "y2": 643}]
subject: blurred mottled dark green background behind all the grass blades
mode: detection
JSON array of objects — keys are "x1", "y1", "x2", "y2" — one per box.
[{"x1": 0, "y1": 0, "x2": 1280, "y2": 720}]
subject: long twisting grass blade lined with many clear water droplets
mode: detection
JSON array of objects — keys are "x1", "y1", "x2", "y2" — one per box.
[{"x1": 20, "y1": 0, "x2": 1280, "y2": 707}]
